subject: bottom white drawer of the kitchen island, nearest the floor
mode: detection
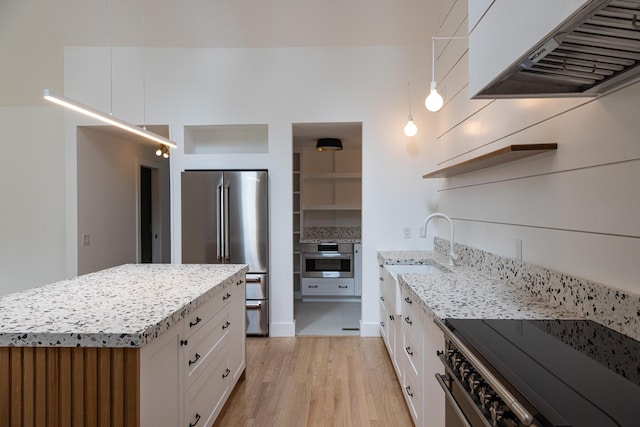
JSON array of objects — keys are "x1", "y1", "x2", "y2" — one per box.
[{"x1": 184, "y1": 344, "x2": 231, "y2": 427}]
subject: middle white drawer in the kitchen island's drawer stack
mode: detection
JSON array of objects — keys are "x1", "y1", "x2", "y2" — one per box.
[{"x1": 183, "y1": 310, "x2": 231, "y2": 390}]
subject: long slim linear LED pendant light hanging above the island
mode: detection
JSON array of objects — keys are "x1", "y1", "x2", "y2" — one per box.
[{"x1": 44, "y1": 0, "x2": 177, "y2": 153}]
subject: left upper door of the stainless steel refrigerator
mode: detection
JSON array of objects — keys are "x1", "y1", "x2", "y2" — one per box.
[{"x1": 181, "y1": 171, "x2": 222, "y2": 264}]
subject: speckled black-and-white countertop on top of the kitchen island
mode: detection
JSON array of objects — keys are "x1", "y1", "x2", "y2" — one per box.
[{"x1": 0, "y1": 264, "x2": 247, "y2": 347}]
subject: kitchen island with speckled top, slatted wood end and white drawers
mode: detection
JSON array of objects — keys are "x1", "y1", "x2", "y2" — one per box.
[{"x1": 0, "y1": 264, "x2": 247, "y2": 426}]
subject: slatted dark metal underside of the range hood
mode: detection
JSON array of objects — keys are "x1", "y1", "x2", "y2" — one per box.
[{"x1": 474, "y1": 0, "x2": 640, "y2": 99}]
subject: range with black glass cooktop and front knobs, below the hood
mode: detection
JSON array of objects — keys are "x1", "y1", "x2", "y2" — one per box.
[{"x1": 436, "y1": 319, "x2": 640, "y2": 427}]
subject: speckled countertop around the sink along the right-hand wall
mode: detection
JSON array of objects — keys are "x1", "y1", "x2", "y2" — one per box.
[{"x1": 378, "y1": 251, "x2": 582, "y2": 321}]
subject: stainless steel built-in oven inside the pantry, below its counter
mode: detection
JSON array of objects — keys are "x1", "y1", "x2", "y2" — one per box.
[{"x1": 301, "y1": 243, "x2": 353, "y2": 278}]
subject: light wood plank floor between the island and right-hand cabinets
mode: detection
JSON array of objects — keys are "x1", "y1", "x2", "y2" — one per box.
[{"x1": 214, "y1": 337, "x2": 413, "y2": 427}]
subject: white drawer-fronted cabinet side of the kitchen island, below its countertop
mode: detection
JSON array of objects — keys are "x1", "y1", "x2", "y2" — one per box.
[{"x1": 140, "y1": 275, "x2": 246, "y2": 427}]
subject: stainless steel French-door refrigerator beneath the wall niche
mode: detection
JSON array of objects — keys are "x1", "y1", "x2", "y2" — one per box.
[{"x1": 182, "y1": 171, "x2": 269, "y2": 335}]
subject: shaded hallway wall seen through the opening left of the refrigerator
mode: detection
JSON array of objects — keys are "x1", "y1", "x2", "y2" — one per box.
[{"x1": 77, "y1": 127, "x2": 170, "y2": 274}]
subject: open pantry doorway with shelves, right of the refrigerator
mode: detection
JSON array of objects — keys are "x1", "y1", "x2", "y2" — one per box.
[{"x1": 292, "y1": 123, "x2": 362, "y2": 336}]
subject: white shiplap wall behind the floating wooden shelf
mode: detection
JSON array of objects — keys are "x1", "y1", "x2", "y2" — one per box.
[{"x1": 437, "y1": 1, "x2": 640, "y2": 293}]
